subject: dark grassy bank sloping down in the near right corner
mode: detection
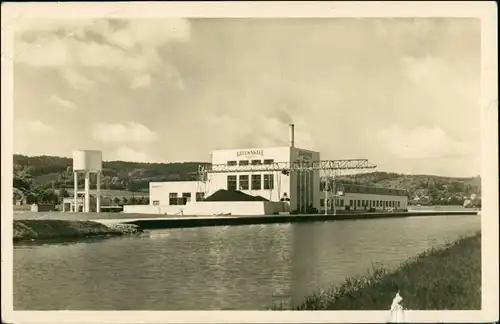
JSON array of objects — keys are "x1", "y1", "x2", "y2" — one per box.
[{"x1": 282, "y1": 233, "x2": 481, "y2": 310}]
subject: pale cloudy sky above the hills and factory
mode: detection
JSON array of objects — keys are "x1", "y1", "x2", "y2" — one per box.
[{"x1": 10, "y1": 18, "x2": 481, "y2": 176}]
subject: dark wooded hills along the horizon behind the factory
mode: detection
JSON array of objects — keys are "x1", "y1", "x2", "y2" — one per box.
[{"x1": 14, "y1": 154, "x2": 481, "y2": 205}]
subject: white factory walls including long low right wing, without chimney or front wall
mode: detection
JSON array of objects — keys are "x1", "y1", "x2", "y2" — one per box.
[{"x1": 134, "y1": 146, "x2": 408, "y2": 215}]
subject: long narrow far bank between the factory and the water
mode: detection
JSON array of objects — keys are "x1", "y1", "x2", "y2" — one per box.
[{"x1": 13, "y1": 212, "x2": 477, "y2": 243}]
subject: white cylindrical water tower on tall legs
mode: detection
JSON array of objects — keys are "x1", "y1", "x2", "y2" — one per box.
[{"x1": 73, "y1": 150, "x2": 102, "y2": 213}]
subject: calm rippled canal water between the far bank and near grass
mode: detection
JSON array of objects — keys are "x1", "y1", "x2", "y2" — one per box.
[{"x1": 14, "y1": 216, "x2": 480, "y2": 310}]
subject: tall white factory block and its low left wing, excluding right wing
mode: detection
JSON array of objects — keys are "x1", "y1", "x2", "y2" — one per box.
[{"x1": 141, "y1": 147, "x2": 320, "y2": 212}]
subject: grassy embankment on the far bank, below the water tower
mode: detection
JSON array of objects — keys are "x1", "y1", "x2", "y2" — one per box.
[{"x1": 12, "y1": 219, "x2": 142, "y2": 242}]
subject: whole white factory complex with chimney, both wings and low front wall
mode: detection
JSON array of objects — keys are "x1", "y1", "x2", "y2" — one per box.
[{"x1": 124, "y1": 125, "x2": 408, "y2": 215}]
